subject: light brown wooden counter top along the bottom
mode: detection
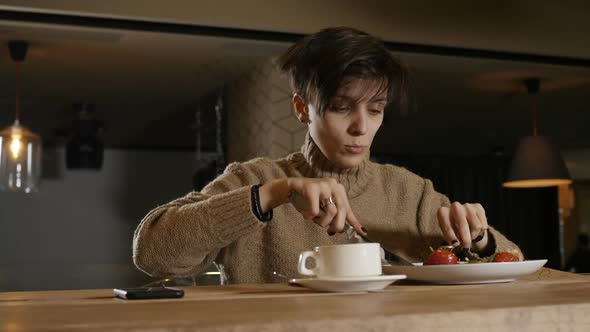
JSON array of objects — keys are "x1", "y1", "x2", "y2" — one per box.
[{"x1": 0, "y1": 268, "x2": 590, "y2": 332}]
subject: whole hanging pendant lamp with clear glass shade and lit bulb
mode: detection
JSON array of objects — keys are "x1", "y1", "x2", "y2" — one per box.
[{"x1": 0, "y1": 41, "x2": 41, "y2": 193}]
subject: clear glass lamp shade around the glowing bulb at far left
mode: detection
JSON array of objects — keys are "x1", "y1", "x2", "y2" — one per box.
[{"x1": 0, "y1": 121, "x2": 42, "y2": 193}]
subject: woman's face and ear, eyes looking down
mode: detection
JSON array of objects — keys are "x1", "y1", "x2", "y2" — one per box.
[{"x1": 307, "y1": 78, "x2": 387, "y2": 168}]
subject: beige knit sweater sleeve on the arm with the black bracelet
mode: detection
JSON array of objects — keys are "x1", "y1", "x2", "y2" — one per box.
[{"x1": 133, "y1": 163, "x2": 264, "y2": 277}]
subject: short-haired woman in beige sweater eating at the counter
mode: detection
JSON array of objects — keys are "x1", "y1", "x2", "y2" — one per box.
[{"x1": 133, "y1": 28, "x2": 522, "y2": 283}]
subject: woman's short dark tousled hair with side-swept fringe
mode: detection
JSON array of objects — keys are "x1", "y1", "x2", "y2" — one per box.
[{"x1": 277, "y1": 27, "x2": 409, "y2": 114}]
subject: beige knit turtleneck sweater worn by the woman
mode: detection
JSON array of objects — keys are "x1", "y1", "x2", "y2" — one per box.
[{"x1": 133, "y1": 135, "x2": 522, "y2": 283}]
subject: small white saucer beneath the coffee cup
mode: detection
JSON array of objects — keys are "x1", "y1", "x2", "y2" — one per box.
[{"x1": 289, "y1": 275, "x2": 406, "y2": 292}]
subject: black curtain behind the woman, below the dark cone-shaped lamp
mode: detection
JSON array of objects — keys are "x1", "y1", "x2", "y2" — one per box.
[{"x1": 373, "y1": 155, "x2": 561, "y2": 269}]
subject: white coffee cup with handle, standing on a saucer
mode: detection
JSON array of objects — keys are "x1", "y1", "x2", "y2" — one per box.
[{"x1": 297, "y1": 243, "x2": 382, "y2": 278}]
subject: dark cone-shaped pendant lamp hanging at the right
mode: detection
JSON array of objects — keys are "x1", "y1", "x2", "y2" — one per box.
[{"x1": 503, "y1": 78, "x2": 572, "y2": 188}]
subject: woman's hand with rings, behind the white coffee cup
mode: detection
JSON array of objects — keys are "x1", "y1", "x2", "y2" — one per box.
[{"x1": 260, "y1": 178, "x2": 366, "y2": 235}]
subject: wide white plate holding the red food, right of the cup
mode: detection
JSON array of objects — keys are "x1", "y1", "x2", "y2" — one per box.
[{"x1": 383, "y1": 259, "x2": 547, "y2": 284}]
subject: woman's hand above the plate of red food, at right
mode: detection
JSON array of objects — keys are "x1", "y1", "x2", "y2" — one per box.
[{"x1": 437, "y1": 202, "x2": 489, "y2": 253}]
